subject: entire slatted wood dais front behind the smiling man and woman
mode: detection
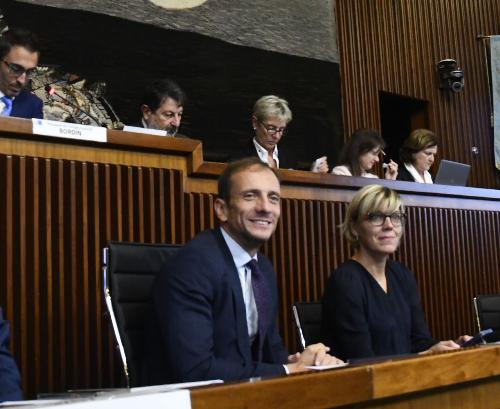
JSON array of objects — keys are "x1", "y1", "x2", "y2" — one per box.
[{"x1": 0, "y1": 150, "x2": 500, "y2": 396}]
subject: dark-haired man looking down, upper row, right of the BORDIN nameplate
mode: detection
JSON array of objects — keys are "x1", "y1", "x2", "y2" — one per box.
[{"x1": 133, "y1": 78, "x2": 186, "y2": 136}]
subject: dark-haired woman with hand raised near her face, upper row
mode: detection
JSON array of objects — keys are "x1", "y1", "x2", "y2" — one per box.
[{"x1": 332, "y1": 129, "x2": 398, "y2": 180}]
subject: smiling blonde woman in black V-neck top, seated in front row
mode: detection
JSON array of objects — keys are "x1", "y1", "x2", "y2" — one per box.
[{"x1": 323, "y1": 185, "x2": 470, "y2": 360}]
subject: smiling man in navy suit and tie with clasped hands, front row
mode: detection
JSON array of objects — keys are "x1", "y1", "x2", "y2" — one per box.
[{"x1": 147, "y1": 158, "x2": 338, "y2": 384}]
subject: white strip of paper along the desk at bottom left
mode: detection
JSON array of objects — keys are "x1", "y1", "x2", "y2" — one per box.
[{"x1": 0, "y1": 389, "x2": 191, "y2": 409}]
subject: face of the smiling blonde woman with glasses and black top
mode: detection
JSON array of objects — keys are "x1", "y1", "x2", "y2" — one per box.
[{"x1": 353, "y1": 205, "x2": 404, "y2": 255}]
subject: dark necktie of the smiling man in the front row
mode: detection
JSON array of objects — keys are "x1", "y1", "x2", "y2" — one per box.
[{"x1": 247, "y1": 259, "x2": 271, "y2": 361}]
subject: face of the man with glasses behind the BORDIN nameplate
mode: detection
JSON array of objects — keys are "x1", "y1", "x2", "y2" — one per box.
[{"x1": 0, "y1": 46, "x2": 38, "y2": 97}]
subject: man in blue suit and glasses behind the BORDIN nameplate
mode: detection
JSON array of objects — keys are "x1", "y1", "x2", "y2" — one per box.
[{"x1": 0, "y1": 28, "x2": 43, "y2": 119}]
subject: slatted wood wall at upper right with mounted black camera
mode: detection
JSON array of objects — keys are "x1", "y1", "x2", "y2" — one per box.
[{"x1": 336, "y1": 0, "x2": 500, "y2": 188}]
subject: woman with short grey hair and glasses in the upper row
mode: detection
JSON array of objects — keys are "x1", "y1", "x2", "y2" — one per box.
[{"x1": 247, "y1": 95, "x2": 328, "y2": 173}]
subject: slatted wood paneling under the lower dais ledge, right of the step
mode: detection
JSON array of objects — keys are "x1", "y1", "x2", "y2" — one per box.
[{"x1": 177, "y1": 190, "x2": 500, "y2": 351}]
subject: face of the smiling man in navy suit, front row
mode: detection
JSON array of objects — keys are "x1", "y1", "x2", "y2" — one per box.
[{"x1": 215, "y1": 166, "x2": 281, "y2": 255}]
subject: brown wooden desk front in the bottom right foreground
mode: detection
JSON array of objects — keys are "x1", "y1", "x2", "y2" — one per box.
[{"x1": 191, "y1": 347, "x2": 500, "y2": 409}]
